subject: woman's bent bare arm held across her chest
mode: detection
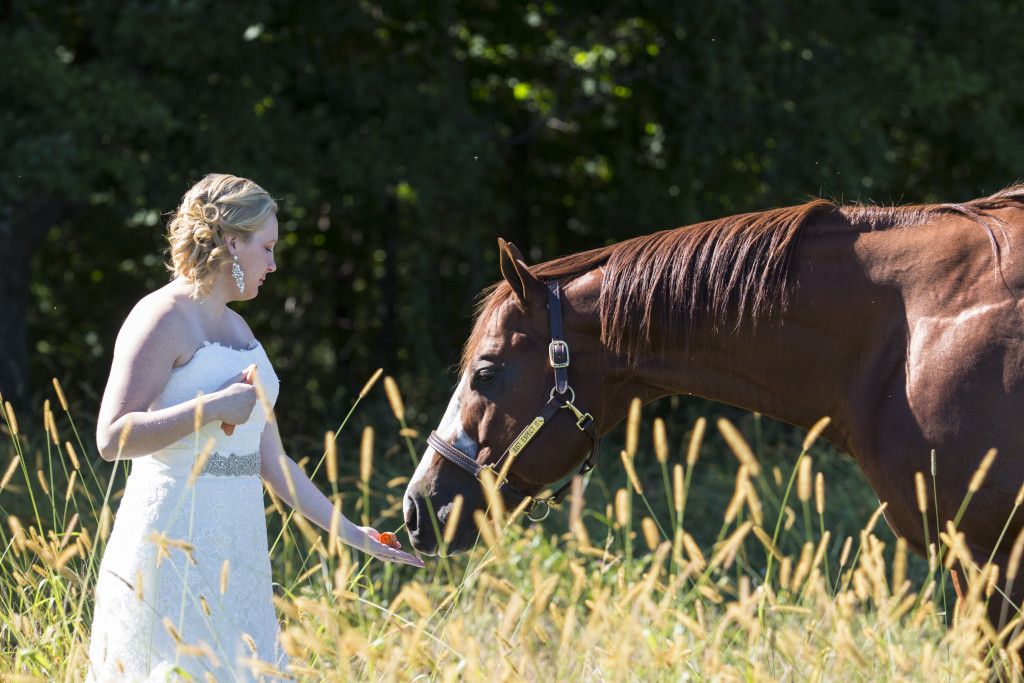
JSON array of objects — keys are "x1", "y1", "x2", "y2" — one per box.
[{"x1": 96, "y1": 295, "x2": 256, "y2": 461}]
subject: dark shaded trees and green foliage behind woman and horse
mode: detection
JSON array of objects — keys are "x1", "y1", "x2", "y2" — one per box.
[{"x1": 0, "y1": 0, "x2": 1024, "y2": 450}]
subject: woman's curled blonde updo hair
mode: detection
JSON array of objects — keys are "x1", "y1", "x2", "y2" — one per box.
[{"x1": 167, "y1": 173, "x2": 278, "y2": 296}]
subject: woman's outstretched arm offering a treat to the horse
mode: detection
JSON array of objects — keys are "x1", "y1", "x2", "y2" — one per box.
[{"x1": 260, "y1": 422, "x2": 424, "y2": 567}]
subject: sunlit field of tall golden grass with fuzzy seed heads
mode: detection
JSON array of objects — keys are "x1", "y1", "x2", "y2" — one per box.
[{"x1": 0, "y1": 378, "x2": 1024, "y2": 681}]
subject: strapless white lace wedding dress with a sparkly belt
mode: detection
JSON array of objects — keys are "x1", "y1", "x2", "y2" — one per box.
[{"x1": 88, "y1": 343, "x2": 287, "y2": 683}]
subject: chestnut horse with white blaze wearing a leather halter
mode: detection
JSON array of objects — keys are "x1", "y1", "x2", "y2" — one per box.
[{"x1": 403, "y1": 184, "x2": 1024, "y2": 626}]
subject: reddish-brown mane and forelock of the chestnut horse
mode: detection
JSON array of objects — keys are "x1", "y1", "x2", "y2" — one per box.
[{"x1": 462, "y1": 183, "x2": 1024, "y2": 371}]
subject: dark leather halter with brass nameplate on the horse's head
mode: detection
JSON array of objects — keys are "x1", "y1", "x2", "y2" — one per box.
[{"x1": 427, "y1": 280, "x2": 601, "y2": 521}]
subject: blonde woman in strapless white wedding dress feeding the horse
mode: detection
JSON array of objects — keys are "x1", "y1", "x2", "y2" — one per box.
[{"x1": 89, "y1": 174, "x2": 423, "y2": 682}]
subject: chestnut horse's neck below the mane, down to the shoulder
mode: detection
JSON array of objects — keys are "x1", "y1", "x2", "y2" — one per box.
[{"x1": 589, "y1": 220, "x2": 905, "y2": 454}]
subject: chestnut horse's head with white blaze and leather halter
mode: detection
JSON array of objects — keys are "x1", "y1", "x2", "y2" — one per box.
[{"x1": 403, "y1": 240, "x2": 603, "y2": 554}]
